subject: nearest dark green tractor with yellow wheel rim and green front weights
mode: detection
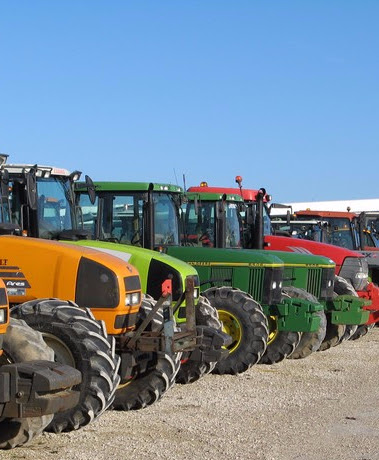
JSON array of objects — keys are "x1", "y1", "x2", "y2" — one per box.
[{"x1": 73, "y1": 182, "x2": 334, "y2": 374}]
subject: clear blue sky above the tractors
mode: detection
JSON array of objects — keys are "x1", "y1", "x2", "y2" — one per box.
[{"x1": 0, "y1": 0, "x2": 379, "y2": 202}]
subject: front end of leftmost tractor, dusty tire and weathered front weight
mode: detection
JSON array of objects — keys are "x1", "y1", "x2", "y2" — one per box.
[{"x1": 0, "y1": 280, "x2": 81, "y2": 449}]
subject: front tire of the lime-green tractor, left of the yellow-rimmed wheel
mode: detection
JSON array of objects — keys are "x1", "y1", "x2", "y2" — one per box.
[{"x1": 176, "y1": 296, "x2": 222, "y2": 384}]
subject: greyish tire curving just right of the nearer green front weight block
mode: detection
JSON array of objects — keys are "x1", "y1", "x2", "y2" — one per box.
[{"x1": 283, "y1": 286, "x2": 327, "y2": 359}]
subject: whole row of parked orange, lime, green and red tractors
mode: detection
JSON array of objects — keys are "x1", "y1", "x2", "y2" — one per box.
[{"x1": 0, "y1": 155, "x2": 379, "y2": 449}]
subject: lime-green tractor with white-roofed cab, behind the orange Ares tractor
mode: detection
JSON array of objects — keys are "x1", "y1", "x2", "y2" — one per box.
[{"x1": 0, "y1": 162, "x2": 230, "y2": 384}]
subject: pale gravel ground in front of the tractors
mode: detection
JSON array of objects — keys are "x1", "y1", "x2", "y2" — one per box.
[{"x1": 0, "y1": 328, "x2": 379, "y2": 460}]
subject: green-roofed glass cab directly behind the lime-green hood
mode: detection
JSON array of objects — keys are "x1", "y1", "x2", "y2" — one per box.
[{"x1": 76, "y1": 182, "x2": 183, "y2": 249}]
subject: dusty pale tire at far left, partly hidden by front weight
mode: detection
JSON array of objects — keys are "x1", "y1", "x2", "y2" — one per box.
[{"x1": 0, "y1": 318, "x2": 54, "y2": 449}]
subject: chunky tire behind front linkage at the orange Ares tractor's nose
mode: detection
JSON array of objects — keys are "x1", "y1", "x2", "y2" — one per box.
[{"x1": 112, "y1": 296, "x2": 181, "y2": 411}]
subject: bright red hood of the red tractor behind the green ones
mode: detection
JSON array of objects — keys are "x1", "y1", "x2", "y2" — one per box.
[{"x1": 265, "y1": 235, "x2": 364, "y2": 271}]
